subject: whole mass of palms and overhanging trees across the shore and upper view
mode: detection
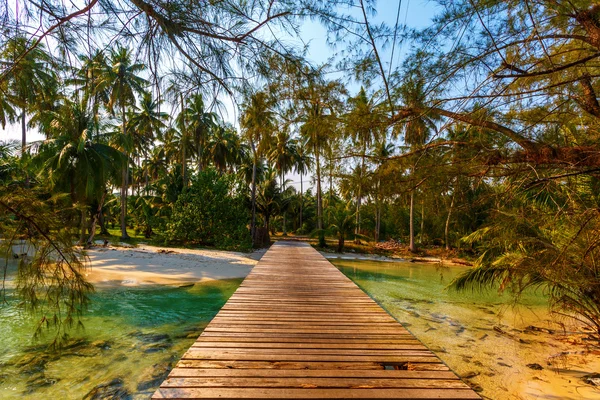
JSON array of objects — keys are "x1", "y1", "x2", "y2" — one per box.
[{"x1": 0, "y1": 0, "x2": 600, "y2": 342}]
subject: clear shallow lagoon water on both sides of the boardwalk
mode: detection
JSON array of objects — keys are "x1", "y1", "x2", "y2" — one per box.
[{"x1": 0, "y1": 259, "x2": 600, "y2": 399}]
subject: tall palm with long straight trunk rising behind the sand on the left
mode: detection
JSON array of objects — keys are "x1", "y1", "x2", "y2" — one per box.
[{"x1": 96, "y1": 46, "x2": 147, "y2": 239}]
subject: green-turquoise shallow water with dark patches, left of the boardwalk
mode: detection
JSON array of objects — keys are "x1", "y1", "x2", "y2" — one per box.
[{"x1": 0, "y1": 279, "x2": 242, "y2": 399}]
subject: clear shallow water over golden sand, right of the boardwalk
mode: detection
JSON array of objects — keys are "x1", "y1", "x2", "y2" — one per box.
[{"x1": 330, "y1": 259, "x2": 600, "y2": 400}]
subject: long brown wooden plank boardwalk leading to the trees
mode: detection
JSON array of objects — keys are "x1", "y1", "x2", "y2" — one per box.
[{"x1": 153, "y1": 242, "x2": 480, "y2": 399}]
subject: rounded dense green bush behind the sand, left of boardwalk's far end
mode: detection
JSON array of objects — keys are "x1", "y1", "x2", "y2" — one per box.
[{"x1": 166, "y1": 169, "x2": 252, "y2": 250}]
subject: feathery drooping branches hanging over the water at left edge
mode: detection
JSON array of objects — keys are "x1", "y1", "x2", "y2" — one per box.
[{"x1": 0, "y1": 186, "x2": 94, "y2": 346}]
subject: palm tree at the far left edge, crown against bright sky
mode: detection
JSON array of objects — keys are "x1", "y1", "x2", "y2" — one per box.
[{"x1": 0, "y1": 36, "x2": 58, "y2": 155}]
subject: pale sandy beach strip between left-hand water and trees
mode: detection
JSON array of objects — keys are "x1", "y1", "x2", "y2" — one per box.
[{"x1": 85, "y1": 245, "x2": 264, "y2": 286}]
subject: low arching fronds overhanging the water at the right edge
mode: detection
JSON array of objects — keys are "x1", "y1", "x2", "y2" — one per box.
[{"x1": 451, "y1": 183, "x2": 600, "y2": 335}]
